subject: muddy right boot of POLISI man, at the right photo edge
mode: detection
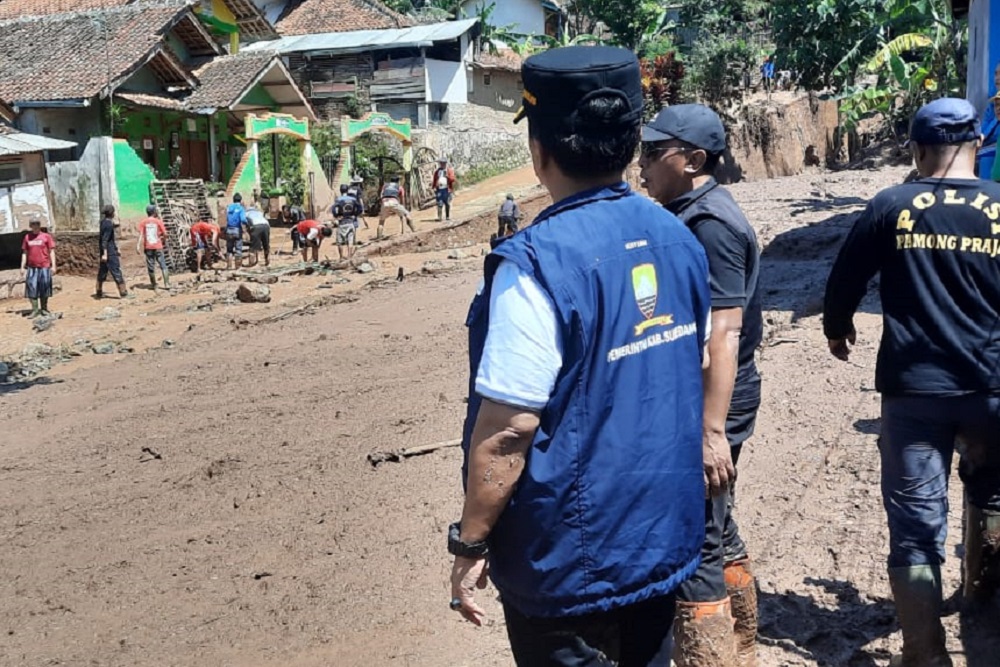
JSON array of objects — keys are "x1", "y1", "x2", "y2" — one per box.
[{"x1": 962, "y1": 503, "x2": 1000, "y2": 608}]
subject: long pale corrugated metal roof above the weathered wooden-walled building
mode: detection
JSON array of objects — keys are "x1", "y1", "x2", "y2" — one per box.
[{"x1": 243, "y1": 18, "x2": 479, "y2": 54}]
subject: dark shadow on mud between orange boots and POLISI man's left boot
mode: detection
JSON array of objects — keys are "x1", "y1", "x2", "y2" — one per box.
[{"x1": 758, "y1": 579, "x2": 897, "y2": 667}]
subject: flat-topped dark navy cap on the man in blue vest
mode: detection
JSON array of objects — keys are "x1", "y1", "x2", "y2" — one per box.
[{"x1": 514, "y1": 46, "x2": 643, "y2": 132}]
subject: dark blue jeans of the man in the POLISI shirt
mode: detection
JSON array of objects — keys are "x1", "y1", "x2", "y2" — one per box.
[{"x1": 879, "y1": 394, "x2": 1000, "y2": 568}]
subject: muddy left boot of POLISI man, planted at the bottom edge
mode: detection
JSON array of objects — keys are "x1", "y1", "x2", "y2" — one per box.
[{"x1": 889, "y1": 565, "x2": 952, "y2": 667}]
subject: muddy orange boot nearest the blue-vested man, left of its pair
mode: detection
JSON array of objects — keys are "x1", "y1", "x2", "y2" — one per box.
[{"x1": 674, "y1": 598, "x2": 738, "y2": 667}]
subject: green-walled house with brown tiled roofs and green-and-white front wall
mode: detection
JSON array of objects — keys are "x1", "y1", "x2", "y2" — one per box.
[{"x1": 0, "y1": 0, "x2": 315, "y2": 229}]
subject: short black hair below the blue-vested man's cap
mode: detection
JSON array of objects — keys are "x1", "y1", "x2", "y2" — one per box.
[{"x1": 528, "y1": 95, "x2": 640, "y2": 178}]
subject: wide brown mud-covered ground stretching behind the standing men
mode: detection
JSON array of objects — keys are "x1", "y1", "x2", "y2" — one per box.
[{"x1": 0, "y1": 163, "x2": 1000, "y2": 667}]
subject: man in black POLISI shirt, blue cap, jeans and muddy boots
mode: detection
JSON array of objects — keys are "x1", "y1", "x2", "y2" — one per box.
[{"x1": 823, "y1": 98, "x2": 1000, "y2": 667}]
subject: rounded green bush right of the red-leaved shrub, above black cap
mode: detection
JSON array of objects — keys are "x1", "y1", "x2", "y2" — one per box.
[{"x1": 683, "y1": 37, "x2": 757, "y2": 112}]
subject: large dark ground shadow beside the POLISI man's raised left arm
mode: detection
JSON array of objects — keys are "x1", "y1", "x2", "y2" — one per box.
[{"x1": 760, "y1": 209, "x2": 881, "y2": 322}]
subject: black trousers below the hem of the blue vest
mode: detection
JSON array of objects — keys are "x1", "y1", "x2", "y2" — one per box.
[{"x1": 503, "y1": 595, "x2": 675, "y2": 667}]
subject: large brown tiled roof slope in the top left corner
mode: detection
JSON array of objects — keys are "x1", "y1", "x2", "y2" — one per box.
[{"x1": 0, "y1": 0, "x2": 190, "y2": 104}]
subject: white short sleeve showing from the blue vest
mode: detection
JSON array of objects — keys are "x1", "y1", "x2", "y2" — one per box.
[{"x1": 476, "y1": 260, "x2": 563, "y2": 411}]
